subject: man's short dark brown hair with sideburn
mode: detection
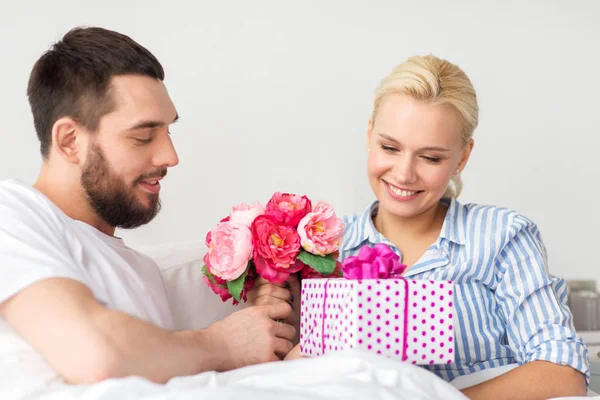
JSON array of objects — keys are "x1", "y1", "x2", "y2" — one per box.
[{"x1": 27, "y1": 27, "x2": 165, "y2": 158}]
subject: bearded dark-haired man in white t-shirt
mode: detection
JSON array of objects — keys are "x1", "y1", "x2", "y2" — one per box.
[{"x1": 0, "y1": 28, "x2": 295, "y2": 384}]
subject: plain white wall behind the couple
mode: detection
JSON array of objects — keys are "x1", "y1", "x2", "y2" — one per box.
[{"x1": 0, "y1": 0, "x2": 600, "y2": 279}]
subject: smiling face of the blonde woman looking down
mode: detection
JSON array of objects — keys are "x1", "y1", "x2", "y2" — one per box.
[{"x1": 367, "y1": 94, "x2": 473, "y2": 218}]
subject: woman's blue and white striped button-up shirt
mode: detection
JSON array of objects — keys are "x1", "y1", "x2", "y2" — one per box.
[{"x1": 340, "y1": 199, "x2": 589, "y2": 383}]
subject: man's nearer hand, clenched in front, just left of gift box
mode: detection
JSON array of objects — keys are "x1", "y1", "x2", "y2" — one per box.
[{"x1": 206, "y1": 301, "x2": 296, "y2": 371}]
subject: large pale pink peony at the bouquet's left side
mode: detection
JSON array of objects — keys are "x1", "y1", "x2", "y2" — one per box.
[{"x1": 204, "y1": 221, "x2": 252, "y2": 281}]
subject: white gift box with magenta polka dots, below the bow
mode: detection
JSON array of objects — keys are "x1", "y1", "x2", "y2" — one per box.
[{"x1": 300, "y1": 278, "x2": 455, "y2": 364}]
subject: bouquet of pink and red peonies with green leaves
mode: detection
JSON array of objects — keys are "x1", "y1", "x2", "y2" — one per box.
[{"x1": 202, "y1": 192, "x2": 344, "y2": 304}]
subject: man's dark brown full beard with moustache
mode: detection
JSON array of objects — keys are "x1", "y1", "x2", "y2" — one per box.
[{"x1": 81, "y1": 144, "x2": 167, "y2": 229}]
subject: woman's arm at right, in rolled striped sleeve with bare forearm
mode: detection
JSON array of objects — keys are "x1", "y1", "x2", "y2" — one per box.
[{"x1": 488, "y1": 215, "x2": 589, "y2": 399}]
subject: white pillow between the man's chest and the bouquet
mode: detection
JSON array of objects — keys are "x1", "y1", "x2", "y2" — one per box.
[{"x1": 139, "y1": 241, "x2": 243, "y2": 330}]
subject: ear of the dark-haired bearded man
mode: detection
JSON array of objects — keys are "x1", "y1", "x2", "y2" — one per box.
[{"x1": 52, "y1": 117, "x2": 85, "y2": 164}]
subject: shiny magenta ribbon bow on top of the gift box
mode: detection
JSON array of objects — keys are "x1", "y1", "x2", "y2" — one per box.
[{"x1": 342, "y1": 243, "x2": 406, "y2": 279}]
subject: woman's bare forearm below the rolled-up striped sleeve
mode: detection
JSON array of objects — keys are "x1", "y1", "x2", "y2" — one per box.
[{"x1": 462, "y1": 361, "x2": 586, "y2": 400}]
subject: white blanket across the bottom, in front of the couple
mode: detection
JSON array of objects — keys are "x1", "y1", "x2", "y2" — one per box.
[{"x1": 5, "y1": 351, "x2": 466, "y2": 400}]
